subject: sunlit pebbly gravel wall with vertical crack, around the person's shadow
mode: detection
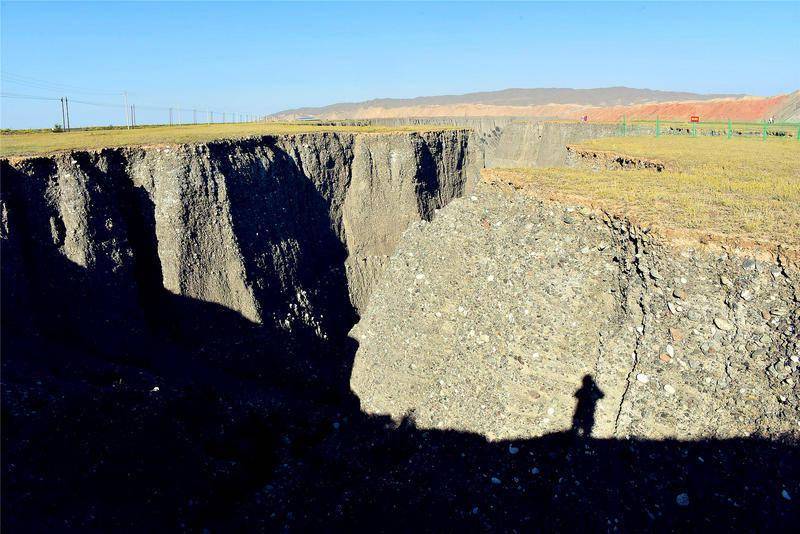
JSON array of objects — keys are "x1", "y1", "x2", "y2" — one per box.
[{"x1": 351, "y1": 183, "x2": 800, "y2": 439}]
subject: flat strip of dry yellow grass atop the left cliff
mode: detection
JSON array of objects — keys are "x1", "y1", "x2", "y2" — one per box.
[{"x1": 0, "y1": 123, "x2": 456, "y2": 157}]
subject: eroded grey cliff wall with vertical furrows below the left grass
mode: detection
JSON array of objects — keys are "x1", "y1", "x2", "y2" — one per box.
[{"x1": 0, "y1": 130, "x2": 478, "y2": 356}]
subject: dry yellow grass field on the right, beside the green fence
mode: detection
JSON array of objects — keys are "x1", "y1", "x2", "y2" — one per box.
[{"x1": 485, "y1": 137, "x2": 800, "y2": 255}]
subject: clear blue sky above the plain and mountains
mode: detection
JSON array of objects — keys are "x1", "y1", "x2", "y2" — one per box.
[{"x1": 0, "y1": 2, "x2": 800, "y2": 128}]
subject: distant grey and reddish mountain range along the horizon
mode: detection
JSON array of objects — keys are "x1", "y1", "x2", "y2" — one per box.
[{"x1": 272, "y1": 87, "x2": 787, "y2": 120}]
